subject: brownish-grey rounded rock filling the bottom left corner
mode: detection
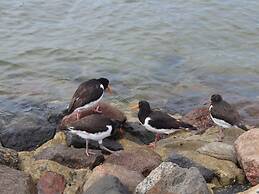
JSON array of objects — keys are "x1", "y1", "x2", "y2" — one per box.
[{"x1": 0, "y1": 165, "x2": 36, "y2": 194}]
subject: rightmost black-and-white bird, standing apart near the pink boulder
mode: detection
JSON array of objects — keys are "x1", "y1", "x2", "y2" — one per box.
[{"x1": 209, "y1": 94, "x2": 247, "y2": 141}]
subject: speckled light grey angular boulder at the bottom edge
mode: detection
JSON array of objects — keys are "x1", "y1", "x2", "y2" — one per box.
[{"x1": 135, "y1": 162, "x2": 210, "y2": 194}]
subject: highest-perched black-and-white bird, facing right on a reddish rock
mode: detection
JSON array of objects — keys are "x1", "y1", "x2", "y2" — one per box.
[{"x1": 66, "y1": 78, "x2": 112, "y2": 119}]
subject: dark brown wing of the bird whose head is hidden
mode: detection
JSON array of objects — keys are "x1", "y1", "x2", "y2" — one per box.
[{"x1": 67, "y1": 114, "x2": 112, "y2": 133}]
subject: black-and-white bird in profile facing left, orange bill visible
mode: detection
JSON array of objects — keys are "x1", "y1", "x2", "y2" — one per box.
[{"x1": 132, "y1": 101, "x2": 197, "y2": 147}]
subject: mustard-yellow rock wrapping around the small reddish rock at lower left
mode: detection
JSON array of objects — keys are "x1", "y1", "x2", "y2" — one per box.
[{"x1": 19, "y1": 152, "x2": 91, "y2": 194}]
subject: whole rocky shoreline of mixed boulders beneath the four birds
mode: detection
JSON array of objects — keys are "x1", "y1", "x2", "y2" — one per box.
[{"x1": 0, "y1": 103, "x2": 259, "y2": 194}]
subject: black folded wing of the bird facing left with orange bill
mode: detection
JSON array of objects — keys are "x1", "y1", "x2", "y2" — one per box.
[{"x1": 148, "y1": 111, "x2": 189, "y2": 129}]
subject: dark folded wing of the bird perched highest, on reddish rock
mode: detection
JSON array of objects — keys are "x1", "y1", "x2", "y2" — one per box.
[{"x1": 68, "y1": 79, "x2": 103, "y2": 114}]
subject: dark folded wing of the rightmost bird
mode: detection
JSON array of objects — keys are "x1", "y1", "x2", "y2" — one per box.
[{"x1": 210, "y1": 101, "x2": 241, "y2": 125}]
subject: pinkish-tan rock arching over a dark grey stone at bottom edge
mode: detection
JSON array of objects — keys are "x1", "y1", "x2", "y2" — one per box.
[{"x1": 83, "y1": 163, "x2": 144, "y2": 192}]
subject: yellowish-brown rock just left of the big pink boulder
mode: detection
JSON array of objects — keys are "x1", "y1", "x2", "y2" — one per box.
[{"x1": 181, "y1": 151, "x2": 245, "y2": 187}]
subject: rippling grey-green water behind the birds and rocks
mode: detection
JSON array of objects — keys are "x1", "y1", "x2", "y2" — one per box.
[{"x1": 0, "y1": 0, "x2": 259, "y2": 119}]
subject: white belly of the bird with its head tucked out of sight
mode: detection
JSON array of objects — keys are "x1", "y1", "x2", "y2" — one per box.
[{"x1": 69, "y1": 125, "x2": 112, "y2": 141}]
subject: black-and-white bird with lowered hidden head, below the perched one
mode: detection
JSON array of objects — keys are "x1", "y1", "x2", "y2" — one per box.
[{"x1": 67, "y1": 114, "x2": 122, "y2": 156}]
